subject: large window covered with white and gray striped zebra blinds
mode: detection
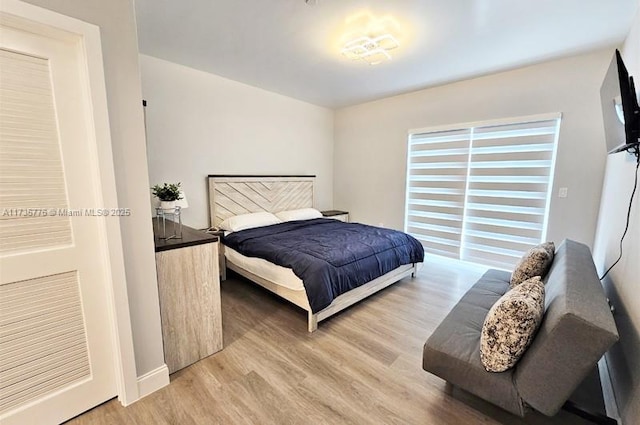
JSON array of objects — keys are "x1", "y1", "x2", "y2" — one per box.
[{"x1": 405, "y1": 114, "x2": 560, "y2": 268}]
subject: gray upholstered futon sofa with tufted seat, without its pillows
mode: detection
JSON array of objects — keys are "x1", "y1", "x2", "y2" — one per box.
[{"x1": 423, "y1": 240, "x2": 618, "y2": 416}]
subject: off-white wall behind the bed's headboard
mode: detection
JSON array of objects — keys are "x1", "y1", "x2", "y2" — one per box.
[{"x1": 140, "y1": 55, "x2": 333, "y2": 228}]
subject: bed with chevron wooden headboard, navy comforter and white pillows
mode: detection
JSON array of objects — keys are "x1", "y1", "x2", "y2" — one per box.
[{"x1": 209, "y1": 176, "x2": 424, "y2": 332}]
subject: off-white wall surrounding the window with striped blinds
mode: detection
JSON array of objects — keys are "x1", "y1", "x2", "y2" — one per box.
[{"x1": 334, "y1": 48, "x2": 613, "y2": 245}]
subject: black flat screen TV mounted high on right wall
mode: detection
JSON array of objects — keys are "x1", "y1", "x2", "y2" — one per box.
[{"x1": 600, "y1": 50, "x2": 640, "y2": 153}]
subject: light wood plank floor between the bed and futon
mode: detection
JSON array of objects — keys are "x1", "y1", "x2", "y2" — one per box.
[{"x1": 69, "y1": 256, "x2": 586, "y2": 425}]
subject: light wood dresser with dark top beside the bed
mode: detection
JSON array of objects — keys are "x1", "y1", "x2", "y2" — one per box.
[{"x1": 153, "y1": 219, "x2": 222, "y2": 373}]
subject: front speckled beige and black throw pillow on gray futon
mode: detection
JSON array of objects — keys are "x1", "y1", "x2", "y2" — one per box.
[{"x1": 480, "y1": 276, "x2": 544, "y2": 372}]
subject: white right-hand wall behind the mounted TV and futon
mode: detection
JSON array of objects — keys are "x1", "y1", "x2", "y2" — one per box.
[{"x1": 594, "y1": 10, "x2": 640, "y2": 425}]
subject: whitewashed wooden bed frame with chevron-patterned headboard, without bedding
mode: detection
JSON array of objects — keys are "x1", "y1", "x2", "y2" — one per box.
[{"x1": 208, "y1": 175, "x2": 416, "y2": 332}]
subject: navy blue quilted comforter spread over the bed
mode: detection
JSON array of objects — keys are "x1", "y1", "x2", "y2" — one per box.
[{"x1": 224, "y1": 218, "x2": 424, "y2": 313}]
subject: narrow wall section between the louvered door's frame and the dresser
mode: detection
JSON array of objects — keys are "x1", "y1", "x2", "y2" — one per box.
[{"x1": 27, "y1": 0, "x2": 164, "y2": 376}]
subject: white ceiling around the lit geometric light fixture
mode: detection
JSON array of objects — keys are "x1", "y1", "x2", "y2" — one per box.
[{"x1": 135, "y1": 0, "x2": 639, "y2": 108}]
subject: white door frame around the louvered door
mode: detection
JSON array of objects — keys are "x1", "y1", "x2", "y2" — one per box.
[{"x1": 0, "y1": 0, "x2": 140, "y2": 406}]
